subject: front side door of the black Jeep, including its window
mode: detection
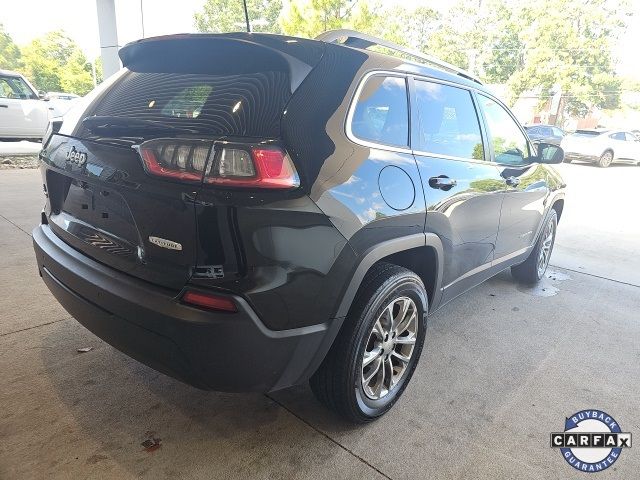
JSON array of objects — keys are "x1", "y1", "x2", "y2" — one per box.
[{"x1": 478, "y1": 94, "x2": 549, "y2": 261}]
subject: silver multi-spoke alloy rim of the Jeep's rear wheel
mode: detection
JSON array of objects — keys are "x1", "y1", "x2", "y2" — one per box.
[{"x1": 361, "y1": 297, "x2": 418, "y2": 400}]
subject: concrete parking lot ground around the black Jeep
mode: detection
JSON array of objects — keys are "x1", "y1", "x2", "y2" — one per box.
[{"x1": 0, "y1": 164, "x2": 640, "y2": 479}]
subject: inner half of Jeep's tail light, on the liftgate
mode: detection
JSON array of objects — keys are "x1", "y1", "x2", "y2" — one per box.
[{"x1": 139, "y1": 139, "x2": 213, "y2": 182}]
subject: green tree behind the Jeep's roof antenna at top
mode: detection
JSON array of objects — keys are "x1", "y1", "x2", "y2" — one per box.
[{"x1": 193, "y1": 0, "x2": 282, "y2": 33}]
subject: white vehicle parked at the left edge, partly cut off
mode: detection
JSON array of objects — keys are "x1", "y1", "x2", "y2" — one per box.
[{"x1": 0, "y1": 70, "x2": 49, "y2": 140}]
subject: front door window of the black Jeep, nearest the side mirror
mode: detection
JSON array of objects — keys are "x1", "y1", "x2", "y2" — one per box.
[{"x1": 478, "y1": 95, "x2": 529, "y2": 165}]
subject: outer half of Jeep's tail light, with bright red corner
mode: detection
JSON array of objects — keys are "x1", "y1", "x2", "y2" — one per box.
[{"x1": 204, "y1": 146, "x2": 300, "y2": 188}]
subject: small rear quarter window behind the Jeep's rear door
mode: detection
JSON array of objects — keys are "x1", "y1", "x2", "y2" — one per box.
[{"x1": 351, "y1": 75, "x2": 409, "y2": 147}]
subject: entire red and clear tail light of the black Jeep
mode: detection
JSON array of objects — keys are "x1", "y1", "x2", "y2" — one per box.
[{"x1": 139, "y1": 139, "x2": 300, "y2": 189}]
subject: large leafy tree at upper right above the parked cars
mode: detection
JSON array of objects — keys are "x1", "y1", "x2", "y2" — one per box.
[{"x1": 508, "y1": 0, "x2": 629, "y2": 116}]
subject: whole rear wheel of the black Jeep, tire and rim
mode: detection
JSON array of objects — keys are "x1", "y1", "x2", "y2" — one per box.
[{"x1": 309, "y1": 263, "x2": 428, "y2": 423}]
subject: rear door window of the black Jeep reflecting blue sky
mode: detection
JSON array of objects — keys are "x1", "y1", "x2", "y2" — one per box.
[{"x1": 415, "y1": 80, "x2": 484, "y2": 160}]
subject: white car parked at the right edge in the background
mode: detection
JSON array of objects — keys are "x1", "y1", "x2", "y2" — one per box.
[{"x1": 560, "y1": 130, "x2": 640, "y2": 167}]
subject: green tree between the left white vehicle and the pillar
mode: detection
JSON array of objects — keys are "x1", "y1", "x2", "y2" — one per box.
[{"x1": 22, "y1": 31, "x2": 93, "y2": 95}]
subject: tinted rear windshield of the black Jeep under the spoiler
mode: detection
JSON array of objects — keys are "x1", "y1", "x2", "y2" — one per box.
[{"x1": 84, "y1": 71, "x2": 291, "y2": 137}]
